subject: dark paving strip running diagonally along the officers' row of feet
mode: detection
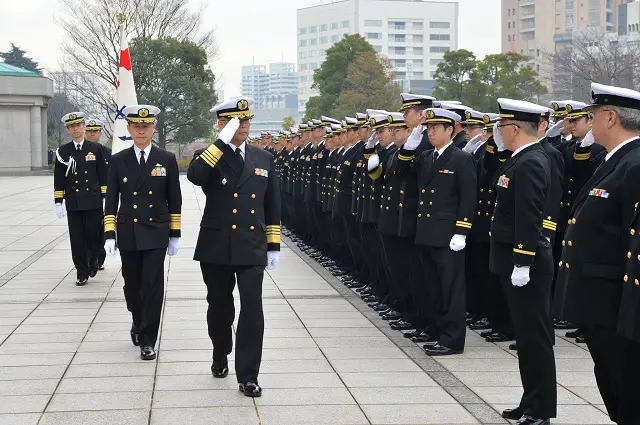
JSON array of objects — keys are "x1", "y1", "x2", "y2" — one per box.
[{"x1": 285, "y1": 238, "x2": 509, "y2": 424}]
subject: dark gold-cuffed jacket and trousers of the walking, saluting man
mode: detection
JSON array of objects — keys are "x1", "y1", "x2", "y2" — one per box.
[{"x1": 187, "y1": 134, "x2": 280, "y2": 384}]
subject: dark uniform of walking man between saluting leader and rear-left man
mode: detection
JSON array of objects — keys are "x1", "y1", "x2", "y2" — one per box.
[{"x1": 104, "y1": 146, "x2": 182, "y2": 347}]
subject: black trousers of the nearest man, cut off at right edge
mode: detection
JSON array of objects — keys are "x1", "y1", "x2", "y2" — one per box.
[{"x1": 584, "y1": 326, "x2": 640, "y2": 425}]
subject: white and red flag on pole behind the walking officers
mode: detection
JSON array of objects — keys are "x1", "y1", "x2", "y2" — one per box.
[{"x1": 111, "y1": 22, "x2": 138, "y2": 154}]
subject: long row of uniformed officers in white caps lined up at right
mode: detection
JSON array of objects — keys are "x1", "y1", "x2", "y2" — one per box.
[{"x1": 272, "y1": 83, "x2": 640, "y2": 425}]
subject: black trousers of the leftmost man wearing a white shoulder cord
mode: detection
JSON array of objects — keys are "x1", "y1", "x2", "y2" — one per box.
[{"x1": 67, "y1": 209, "x2": 103, "y2": 279}]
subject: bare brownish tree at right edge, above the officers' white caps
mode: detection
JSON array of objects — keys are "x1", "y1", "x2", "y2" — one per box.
[{"x1": 545, "y1": 28, "x2": 640, "y2": 100}]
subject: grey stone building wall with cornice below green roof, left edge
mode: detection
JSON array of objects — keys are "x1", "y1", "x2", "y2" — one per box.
[{"x1": 0, "y1": 75, "x2": 53, "y2": 173}]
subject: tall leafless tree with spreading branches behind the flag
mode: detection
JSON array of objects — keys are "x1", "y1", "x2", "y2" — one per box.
[{"x1": 51, "y1": 0, "x2": 218, "y2": 129}]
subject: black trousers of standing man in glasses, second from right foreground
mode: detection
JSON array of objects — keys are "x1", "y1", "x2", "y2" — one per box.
[{"x1": 500, "y1": 268, "x2": 557, "y2": 419}]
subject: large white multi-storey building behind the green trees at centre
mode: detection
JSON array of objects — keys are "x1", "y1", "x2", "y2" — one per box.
[{"x1": 297, "y1": 0, "x2": 458, "y2": 113}]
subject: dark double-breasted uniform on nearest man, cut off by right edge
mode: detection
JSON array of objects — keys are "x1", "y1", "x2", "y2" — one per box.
[{"x1": 555, "y1": 138, "x2": 640, "y2": 424}]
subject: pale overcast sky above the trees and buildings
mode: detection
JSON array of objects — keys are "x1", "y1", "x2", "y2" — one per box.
[{"x1": 0, "y1": 0, "x2": 500, "y2": 97}]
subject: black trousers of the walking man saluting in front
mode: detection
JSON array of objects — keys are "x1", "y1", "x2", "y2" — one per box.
[{"x1": 200, "y1": 262, "x2": 264, "y2": 384}]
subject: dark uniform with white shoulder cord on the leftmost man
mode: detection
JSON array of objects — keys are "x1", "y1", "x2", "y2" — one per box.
[{"x1": 53, "y1": 137, "x2": 107, "y2": 282}]
